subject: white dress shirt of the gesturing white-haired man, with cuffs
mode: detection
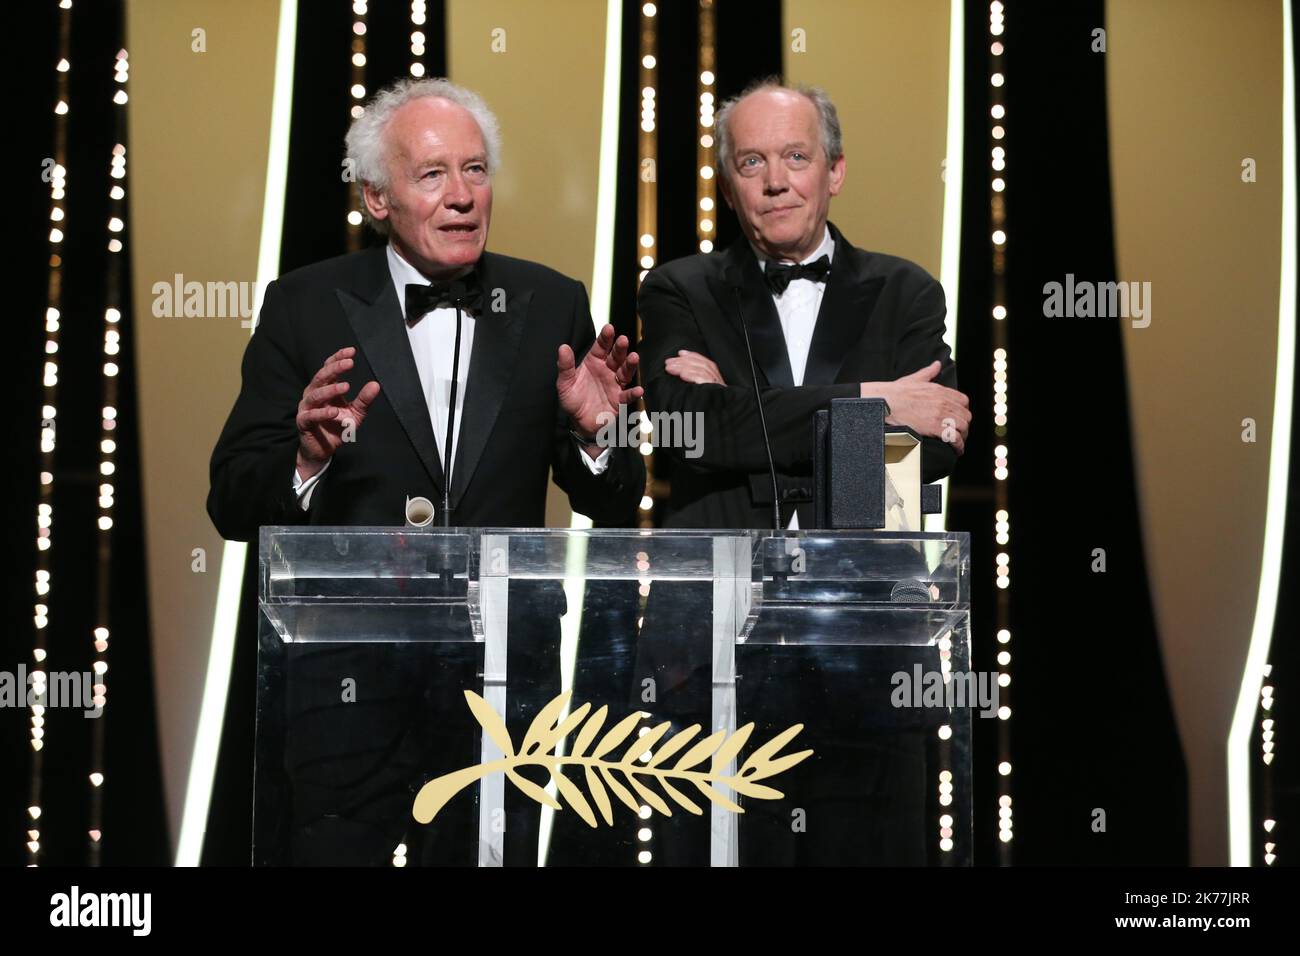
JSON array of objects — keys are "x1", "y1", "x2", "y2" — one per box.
[{"x1": 294, "y1": 243, "x2": 605, "y2": 511}]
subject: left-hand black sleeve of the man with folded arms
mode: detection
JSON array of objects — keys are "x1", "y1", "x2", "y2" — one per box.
[{"x1": 637, "y1": 272, "x2": 861, "y2": 473}]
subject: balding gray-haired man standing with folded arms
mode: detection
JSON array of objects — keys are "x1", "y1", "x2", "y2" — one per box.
[{"x1": 637, "y1": 79, "x2": 971, "y2": 528}]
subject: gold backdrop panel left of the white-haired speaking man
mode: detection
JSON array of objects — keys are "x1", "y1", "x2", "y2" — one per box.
[{"x1": 126, "y1": 0, "x2": 289, "y2": 844}]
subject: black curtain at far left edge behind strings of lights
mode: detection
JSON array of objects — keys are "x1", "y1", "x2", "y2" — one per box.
[{"x1": 0, "y1": 0, "x2": 170, "y2": 866}]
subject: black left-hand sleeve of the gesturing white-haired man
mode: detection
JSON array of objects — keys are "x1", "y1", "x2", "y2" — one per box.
[{"x1": 208, "y1": 282, "x2": 318, "y2": 541}]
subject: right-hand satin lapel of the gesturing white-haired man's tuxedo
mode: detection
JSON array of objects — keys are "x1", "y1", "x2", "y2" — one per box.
[{"x1": 451, "y1": 252, "x2": 533, "y2": 507}]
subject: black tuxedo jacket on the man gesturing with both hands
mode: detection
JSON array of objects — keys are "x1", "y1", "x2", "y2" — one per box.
[{"x1": 208, "y1": 247, "x2": 645, "y2": 541}]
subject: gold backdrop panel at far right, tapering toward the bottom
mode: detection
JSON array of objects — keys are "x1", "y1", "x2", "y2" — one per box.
[{"x1": 1102, "y1": 0, "x2": 1294, "y2": 865}]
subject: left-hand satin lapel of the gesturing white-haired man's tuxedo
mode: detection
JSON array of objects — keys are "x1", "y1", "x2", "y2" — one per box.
[{"x1": 334, "y1": 247, "x2": 447, "y2": 498}]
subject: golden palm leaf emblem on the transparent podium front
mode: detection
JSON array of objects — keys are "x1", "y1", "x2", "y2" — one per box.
[{"x1": 412, "y1": 691, "x2": 813, "y2": 827}]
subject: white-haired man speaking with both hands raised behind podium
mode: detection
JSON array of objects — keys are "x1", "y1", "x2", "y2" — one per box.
[{"x1": 208, "y1": 79, "x2": 645, "y2": 540}]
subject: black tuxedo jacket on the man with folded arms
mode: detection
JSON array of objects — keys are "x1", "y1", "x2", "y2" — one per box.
[{"x1": 637, "y1": 225, "x2": 957, "y2": 528}]
